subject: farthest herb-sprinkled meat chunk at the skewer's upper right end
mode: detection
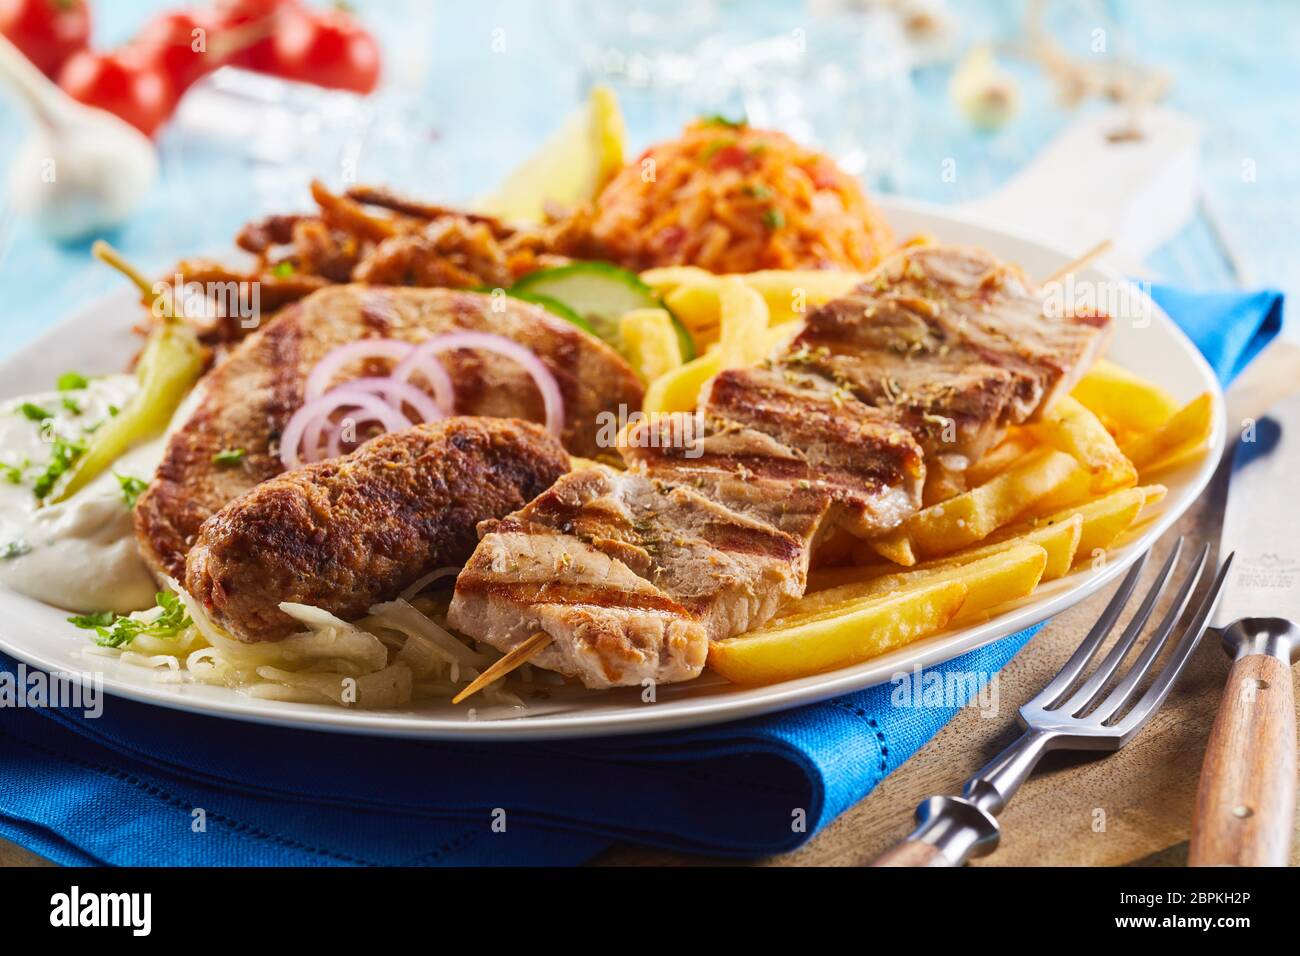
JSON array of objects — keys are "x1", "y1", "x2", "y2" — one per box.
[{"x1": 788, "y1": 246, "x2": 1110, "y2": 471}]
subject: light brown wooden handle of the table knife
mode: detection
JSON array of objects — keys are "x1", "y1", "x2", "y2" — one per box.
[{"x1": 1187, "y1": 654, "x2": 1296, "y2": 866}]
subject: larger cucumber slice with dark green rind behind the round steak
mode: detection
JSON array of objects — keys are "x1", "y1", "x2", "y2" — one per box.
[{"x1": 511, "y1": 263, "x2": 696, "y2": 362}]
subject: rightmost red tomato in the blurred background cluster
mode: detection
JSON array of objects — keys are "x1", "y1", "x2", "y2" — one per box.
[{"x1": 269, "y1": 7, "x2": 380, "y2": 92}]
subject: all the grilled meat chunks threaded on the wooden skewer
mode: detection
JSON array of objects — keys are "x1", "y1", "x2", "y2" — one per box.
[{"x1": 451, "y1": 248, "x2": 1109, "y2": 687}]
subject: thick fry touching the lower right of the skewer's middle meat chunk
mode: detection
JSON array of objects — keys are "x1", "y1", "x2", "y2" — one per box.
[{"x1": 871, "y1": 449, "x2": 1076, "y2": 566}]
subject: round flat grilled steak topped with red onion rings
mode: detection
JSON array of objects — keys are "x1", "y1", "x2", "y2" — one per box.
[{"x1": 135, "y1": 285, "x2": 642, "y2": 578}]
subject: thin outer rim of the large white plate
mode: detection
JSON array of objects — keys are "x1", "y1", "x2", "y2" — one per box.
[{"x1": 0, "y1": 195, "x2": 1227, "y2": 741}]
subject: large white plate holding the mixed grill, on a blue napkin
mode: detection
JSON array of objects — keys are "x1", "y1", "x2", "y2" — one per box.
[{"x1": 0, "y1": 199, "x2": 1226, "y2": 740}]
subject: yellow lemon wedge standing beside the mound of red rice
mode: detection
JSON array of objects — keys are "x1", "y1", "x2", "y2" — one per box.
[{"x1": 478, "y1": 86, "x2": 625, "y2": 222}]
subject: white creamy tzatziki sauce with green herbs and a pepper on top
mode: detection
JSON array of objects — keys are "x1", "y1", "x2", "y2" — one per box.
[{"x1": 0, "y1": 375, "x2": 164, "y2": 614}]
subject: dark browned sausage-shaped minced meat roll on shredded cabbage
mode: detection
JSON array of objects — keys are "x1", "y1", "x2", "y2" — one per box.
[{"x1": 185, "y1": 418, "x2": 568, "y2": 641}]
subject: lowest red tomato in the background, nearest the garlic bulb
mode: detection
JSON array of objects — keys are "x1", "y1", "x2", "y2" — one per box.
[{"x1": 59, "y1": 49, "x2": 176, "y2": 137}]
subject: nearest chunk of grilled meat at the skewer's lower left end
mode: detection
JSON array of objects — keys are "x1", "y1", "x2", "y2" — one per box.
[{"x1": 449, "y1": 466, "x2": 809, "y2": 687}]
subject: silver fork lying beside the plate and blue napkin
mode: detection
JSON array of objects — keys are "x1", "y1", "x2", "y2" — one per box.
[{"x1": 872, "y1": 538, "x2": 1232, "y2": 866}]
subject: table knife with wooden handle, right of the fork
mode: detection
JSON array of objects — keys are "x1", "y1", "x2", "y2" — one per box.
[{"x1": 1188, "y1": 395, "x2": 1300, "y2": 866}]
